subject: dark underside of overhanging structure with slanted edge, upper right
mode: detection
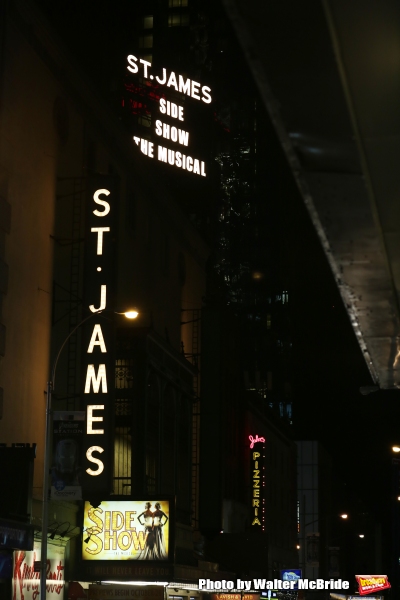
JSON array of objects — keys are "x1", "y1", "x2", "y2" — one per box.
[{"x1": 223, "y1": 0, "x2": 400, "y2": 389}]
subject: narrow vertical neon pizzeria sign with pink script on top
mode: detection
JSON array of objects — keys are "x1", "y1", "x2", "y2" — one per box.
[{"x1": 249, "y1": 435, "x2": 265, "y2": 531}]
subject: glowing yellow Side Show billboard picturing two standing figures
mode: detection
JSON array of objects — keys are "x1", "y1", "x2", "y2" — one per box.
[{"x1": 82, "y1": 500, "x2": 170, "y2": 561}]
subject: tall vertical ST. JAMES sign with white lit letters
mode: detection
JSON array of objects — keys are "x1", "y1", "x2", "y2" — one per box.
[{"x1": 82, "y1": 176, "x2": 117, "y2": 494}]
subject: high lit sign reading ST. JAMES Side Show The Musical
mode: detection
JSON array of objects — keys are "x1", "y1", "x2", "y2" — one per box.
[{"x1": 127, "y1": 54, "x2": 212, "y2": 177}]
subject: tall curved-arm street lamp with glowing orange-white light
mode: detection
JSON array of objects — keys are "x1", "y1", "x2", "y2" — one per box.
[{"x1": 40, "y1": 310, "x2": 135, "y2": 600}]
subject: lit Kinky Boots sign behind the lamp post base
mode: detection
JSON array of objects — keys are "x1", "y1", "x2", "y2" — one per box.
[{"x1": 12, "y1": 542, "x2": 65, "y2": 600}]
